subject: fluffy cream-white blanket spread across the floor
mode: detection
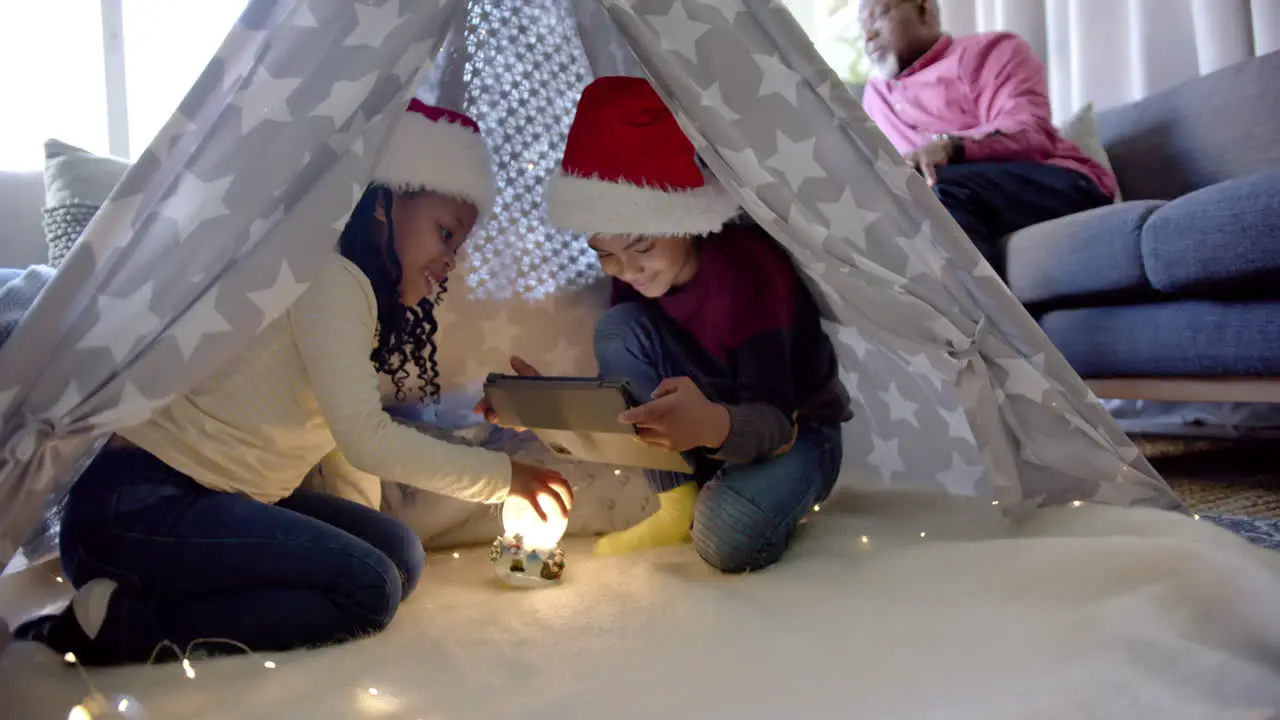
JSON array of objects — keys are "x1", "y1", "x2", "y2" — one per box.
[{"x1": 0, "y1": 495, "x2": 1280, "y2": 720}]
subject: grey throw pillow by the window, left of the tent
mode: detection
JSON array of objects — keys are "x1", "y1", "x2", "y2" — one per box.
[{"x1": 44, "y1": 140, "x2": 129, "y2": 268}]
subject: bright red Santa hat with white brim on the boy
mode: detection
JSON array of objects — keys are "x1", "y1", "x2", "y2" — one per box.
[{"x1": 545, "y1": 77, "x2": 739, "y2": 236}]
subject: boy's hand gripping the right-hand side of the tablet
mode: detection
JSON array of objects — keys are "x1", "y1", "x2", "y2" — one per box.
[{"x1": 618, "y1": 378, "x2": 730, "y2": 452}]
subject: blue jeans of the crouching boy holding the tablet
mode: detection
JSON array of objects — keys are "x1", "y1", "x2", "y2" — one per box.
[{"x1": 595, "y1": 302, "x2": 844, "y2": 573}]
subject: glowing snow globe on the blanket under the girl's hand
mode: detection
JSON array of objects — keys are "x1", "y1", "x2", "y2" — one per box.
[{"x1": 489, "y1": 489, "x2": 568, "y2": 588}]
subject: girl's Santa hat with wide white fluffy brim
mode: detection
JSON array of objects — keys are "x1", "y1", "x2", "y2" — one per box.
[{"x1": 371, "y1": 97, "x2": 498, "y2": 218}]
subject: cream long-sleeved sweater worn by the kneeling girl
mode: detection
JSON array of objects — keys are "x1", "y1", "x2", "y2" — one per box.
[{"x1": 119, "y1": 255, "x2": 511, "y2": 506}]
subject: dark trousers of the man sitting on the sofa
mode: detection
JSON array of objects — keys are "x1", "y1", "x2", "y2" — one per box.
[{"x1": 933, "y1": 163, "x2": 1112, "y2": 274}]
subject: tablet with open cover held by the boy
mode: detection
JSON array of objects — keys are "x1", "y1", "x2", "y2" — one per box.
[{"x1": 484, "y1": 374, "x2": 694, "y2": 473}]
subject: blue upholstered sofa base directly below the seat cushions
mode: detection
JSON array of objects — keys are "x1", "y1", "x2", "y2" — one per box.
[{"x1": 1041, "y1": 300, "x2": 1280, "y2": 378}]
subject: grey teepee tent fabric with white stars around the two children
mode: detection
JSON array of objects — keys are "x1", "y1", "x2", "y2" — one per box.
[{"x1": 0, "y1": 0, "x2": 1185, "y2": 559}]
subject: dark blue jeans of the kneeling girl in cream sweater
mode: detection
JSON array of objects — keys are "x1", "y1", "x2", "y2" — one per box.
[{"x1": 60, "y1": 448, "x2": 425, "y2": 664}]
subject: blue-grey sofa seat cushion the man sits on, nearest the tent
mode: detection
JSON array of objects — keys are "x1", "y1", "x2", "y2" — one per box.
[{"x1": 1005, "y1": 200, "x2": 1164, "y2": 306}]
